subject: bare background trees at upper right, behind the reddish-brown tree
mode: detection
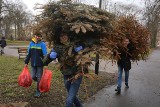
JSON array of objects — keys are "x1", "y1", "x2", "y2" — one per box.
[{"x1": 73, "y1": 0, "x2": 160, "y2": 47}]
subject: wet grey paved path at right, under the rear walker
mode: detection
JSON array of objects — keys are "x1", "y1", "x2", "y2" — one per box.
[{"x1": 84, "y1": 49, "x2": 160, "y2": 107}]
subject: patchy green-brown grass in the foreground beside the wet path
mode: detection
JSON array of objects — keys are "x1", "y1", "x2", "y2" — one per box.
[{"x1": 0, "y1": 56, "x2": 116, "y2": 107}]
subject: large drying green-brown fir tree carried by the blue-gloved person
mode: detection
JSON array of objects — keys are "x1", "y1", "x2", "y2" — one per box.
[{"x1": 34, "y1": 1, "x2": 115, "y2": 65}]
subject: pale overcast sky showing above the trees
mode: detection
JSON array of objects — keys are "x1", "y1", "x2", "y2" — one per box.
[{"x1": 22, "y1": 0, "x2": 144, "y2": 12}]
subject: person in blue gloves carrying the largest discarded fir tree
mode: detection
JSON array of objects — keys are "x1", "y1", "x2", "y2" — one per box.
[{"x1": 44, "y1": 29, "x2": 84, "y2": 107}]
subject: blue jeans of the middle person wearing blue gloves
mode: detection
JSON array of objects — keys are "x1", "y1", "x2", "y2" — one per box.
[{"x1": 64, "y1": 75, "x2": 82, "y2": 107}]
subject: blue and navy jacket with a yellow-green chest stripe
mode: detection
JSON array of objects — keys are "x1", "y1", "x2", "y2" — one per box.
[{"x1": 25, "y1": 38, "x2": 47, "y2": 67}]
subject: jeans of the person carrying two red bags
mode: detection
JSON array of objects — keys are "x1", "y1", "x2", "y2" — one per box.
[{"x1": 31, "y1": 66, "x2": 43, "y2": 91}]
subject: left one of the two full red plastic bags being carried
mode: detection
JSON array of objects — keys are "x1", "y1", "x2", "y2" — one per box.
[{"x1": 18, "y1": 67, "x2": 32, "y2": 88}]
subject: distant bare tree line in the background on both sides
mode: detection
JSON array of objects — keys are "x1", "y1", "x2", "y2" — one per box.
[{"x1": 0, "y1": 0, "x2": 160, "y2": 47}]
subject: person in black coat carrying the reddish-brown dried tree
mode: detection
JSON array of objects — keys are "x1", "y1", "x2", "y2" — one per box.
[{"x1": 114, "y1": 38, "x2": 133, "y2": 94}]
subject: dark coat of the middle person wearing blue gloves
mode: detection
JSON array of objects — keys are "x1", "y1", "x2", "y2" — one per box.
[{"x1": 44, "y1": 44, "x2": 87, "y2": 76}]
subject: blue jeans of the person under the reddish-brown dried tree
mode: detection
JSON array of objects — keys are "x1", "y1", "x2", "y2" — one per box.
[{"x1": 117, "y1": 65, "x2": 129, "y2": 89}]
